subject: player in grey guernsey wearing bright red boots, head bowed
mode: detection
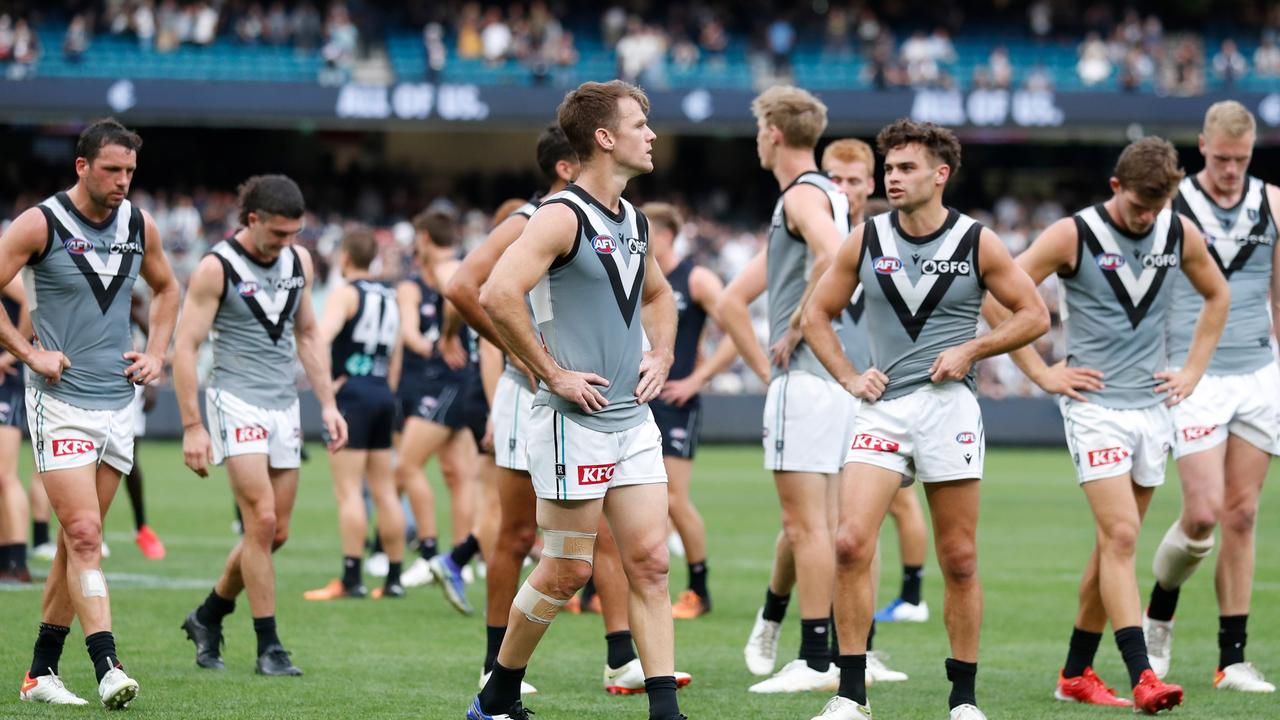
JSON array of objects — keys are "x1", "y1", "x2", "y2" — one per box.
[{"x1": 987, "y1": 137, "x2": 1230, "y2": 714}]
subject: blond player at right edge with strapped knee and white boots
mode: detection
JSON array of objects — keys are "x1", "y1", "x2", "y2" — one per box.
[{"x1": 1143, "y1": 100, "x2": 1280, "y2": 693}]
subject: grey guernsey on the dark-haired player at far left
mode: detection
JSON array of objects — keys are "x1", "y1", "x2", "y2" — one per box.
[{"x1": 22, "y1": 192, "x2": 146, "y2": 410}]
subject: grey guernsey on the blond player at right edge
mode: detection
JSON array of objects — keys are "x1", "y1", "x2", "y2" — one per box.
[{"x1": 1169, "y1": 176, "x2": 1276, "y2": 375}]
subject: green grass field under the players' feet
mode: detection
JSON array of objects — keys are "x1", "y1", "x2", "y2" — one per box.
[{"x1": 0, "y1": 442, "x2": 1280, "y2": 720}]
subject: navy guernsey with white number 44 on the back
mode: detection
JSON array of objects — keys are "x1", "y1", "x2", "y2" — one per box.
[{"x1": 332, "y1": 279, "x2": 399, "y2": 384}]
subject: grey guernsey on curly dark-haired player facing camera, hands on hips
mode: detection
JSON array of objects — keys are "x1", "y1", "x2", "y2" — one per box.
[{"x1": 858, "y1": 209, "x2": 986, "y2": 400}]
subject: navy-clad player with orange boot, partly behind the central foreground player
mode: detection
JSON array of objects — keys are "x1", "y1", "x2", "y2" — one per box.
[{"x1": 640, "y1": 202, "x2": 737, "y2": 620}]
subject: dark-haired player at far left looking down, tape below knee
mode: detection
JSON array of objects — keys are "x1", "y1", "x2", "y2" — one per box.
[{"x1": 0, "y1": 119, "x2": 179, "y2": 708}]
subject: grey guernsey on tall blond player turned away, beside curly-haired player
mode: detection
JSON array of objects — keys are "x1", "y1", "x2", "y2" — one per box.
[{"x1": 768, "y1": 170, "x2": 849, "y2": 380}]
